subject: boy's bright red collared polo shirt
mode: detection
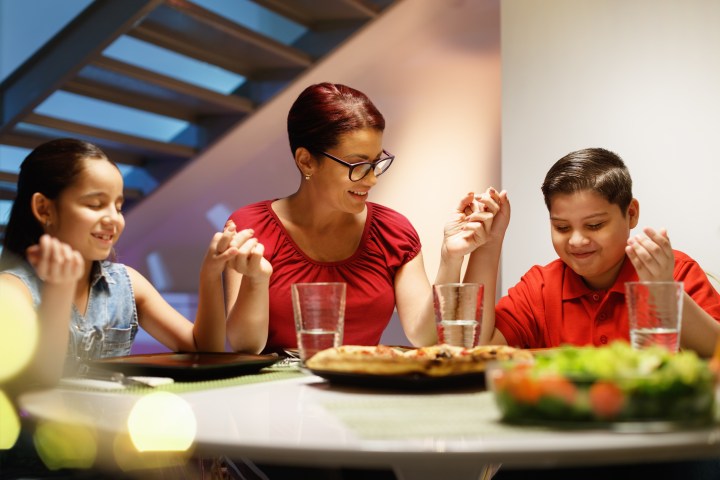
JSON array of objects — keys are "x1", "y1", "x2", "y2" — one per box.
[{"x1": 495, "y1": 250, "x2": 720, "y2": 348}]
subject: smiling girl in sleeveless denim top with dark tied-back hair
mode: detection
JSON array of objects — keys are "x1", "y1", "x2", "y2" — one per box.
[{"x1": 0, "y1": 139, "x2": 262, "y2": 383}]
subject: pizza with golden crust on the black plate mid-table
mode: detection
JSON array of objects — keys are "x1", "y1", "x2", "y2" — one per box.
[{"x1": 306, "y1": 344, "x2": 533, "y2": 377}]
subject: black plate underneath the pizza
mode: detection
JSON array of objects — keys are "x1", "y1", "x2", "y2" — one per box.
[{"x1": 308, "y1": 369, "x2": 485, "y2": 390}]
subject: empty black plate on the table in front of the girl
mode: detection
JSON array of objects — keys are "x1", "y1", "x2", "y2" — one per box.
[{"x1": 88, "y1": 352, "x2": 280, "y2": 381}]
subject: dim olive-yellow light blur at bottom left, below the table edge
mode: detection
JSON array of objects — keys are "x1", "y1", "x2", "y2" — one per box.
[{"x1": 33, "y1": 422, "x2": 98, "y2": 470}]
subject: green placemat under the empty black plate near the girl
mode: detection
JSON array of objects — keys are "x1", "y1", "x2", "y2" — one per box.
[{"x1": 62, "y1": 364, "x2": 307, "y2": 395}]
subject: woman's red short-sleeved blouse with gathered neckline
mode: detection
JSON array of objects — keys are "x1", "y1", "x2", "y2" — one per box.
[{"x1": 230, "y1": 200, "x2": 421, "y2": 351}]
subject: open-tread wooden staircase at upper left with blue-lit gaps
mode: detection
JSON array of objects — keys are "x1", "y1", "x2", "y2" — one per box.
[{"x1": 0, "y1": 0, "x2": 398, "y2": 239}]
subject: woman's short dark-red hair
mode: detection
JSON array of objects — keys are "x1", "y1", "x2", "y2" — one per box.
[{"x1": 288, "y1": 82, "x2": 385, "y2": 155}]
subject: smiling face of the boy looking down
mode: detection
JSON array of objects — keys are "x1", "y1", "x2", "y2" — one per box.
[{"x1": 550, "y1": 190, "x2": 639, "y2": 290}]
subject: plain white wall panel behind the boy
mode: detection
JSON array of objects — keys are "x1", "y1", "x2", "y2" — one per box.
[{"x1": 501, "y1": 0, "x2": 720, "y2": 291}]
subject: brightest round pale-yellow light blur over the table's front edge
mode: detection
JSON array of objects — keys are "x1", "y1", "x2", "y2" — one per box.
[{"x1": 128, "y1": 392, "x2": 197, "y2": 452}]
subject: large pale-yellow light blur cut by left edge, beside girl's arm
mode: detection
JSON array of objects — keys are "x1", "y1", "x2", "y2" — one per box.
[{"x1": 0, "y1": 282, "x2": 38, "y2": 383}]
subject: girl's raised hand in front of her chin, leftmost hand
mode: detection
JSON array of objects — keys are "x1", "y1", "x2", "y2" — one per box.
[{"x1": 26, "y1": 235, "x2": 85, "y2": 284}]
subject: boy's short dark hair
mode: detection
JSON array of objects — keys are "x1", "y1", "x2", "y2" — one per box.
[{"x1": 542, "y1": 148, "x2": 633, "y2": 215}]
